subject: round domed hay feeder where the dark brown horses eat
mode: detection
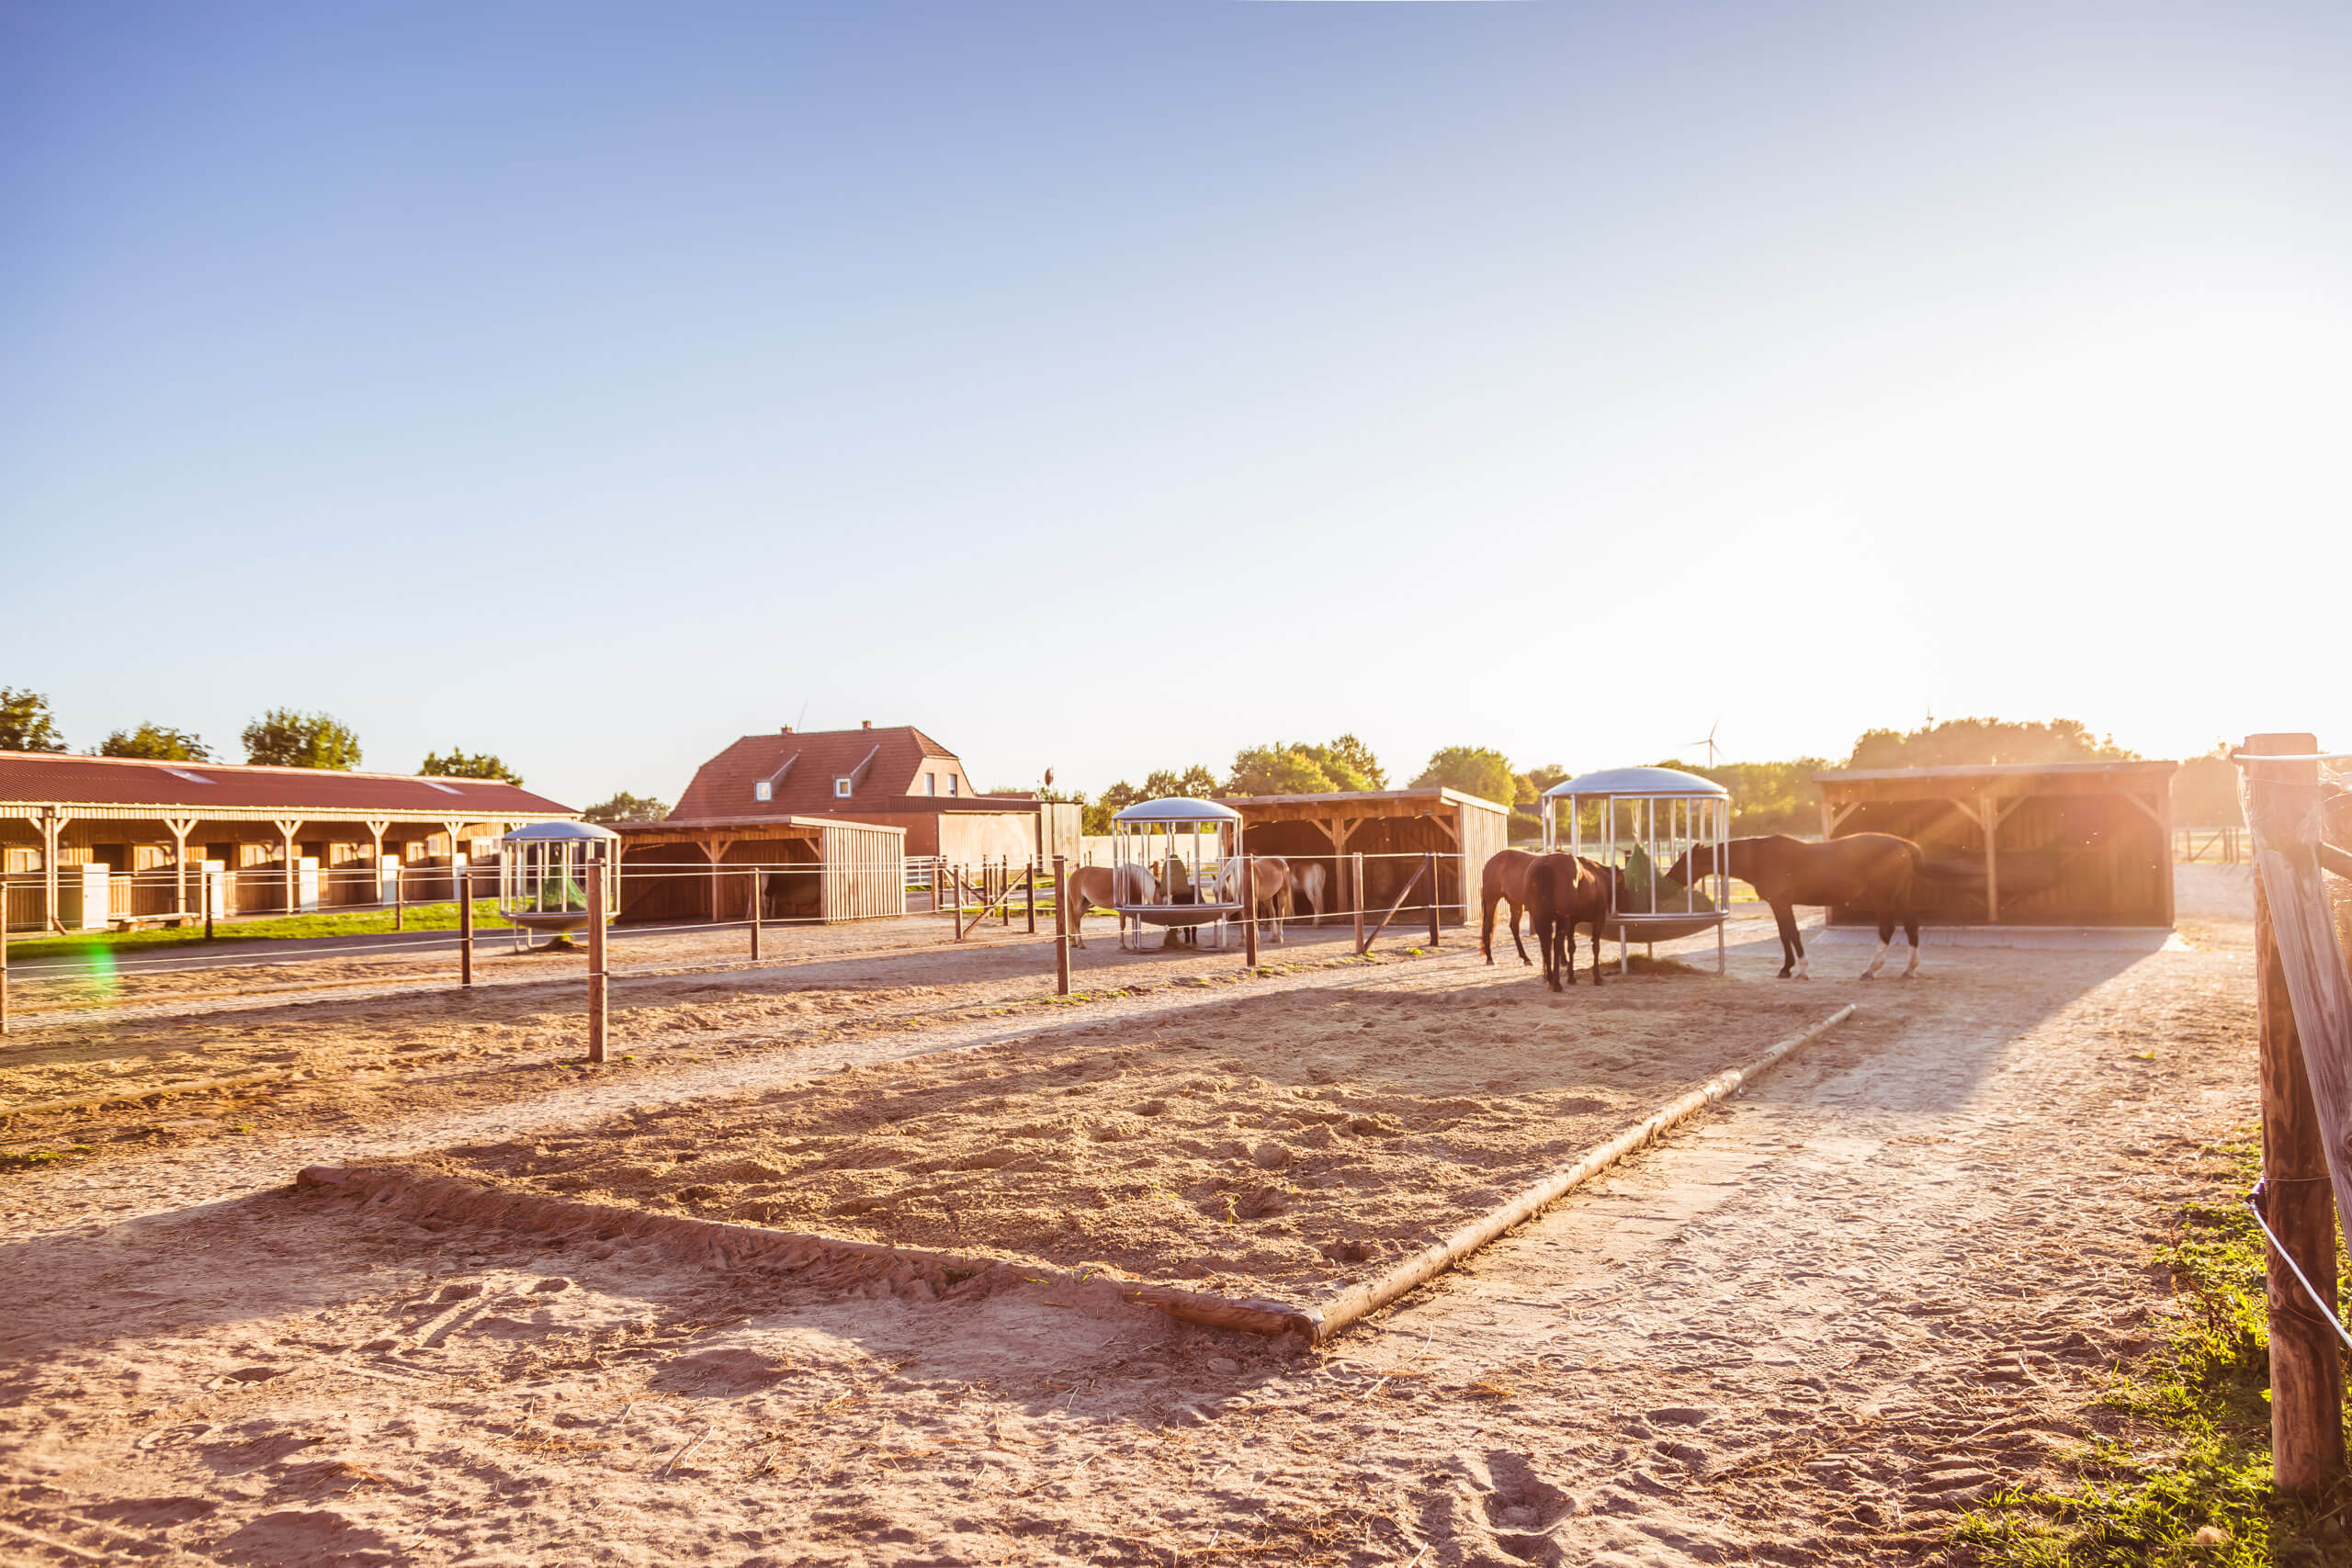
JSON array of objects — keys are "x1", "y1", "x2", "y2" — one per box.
[{"x1": 1543, "y1": 769, "x2": 1731, "y2": 974}]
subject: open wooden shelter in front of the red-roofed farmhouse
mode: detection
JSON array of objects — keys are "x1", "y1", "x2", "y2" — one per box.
[{"x1": 614, "y1": 816, "x2": 906, "y2": 921}]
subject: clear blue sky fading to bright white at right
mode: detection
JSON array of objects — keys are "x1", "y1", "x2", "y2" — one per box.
[{"x1": 0, "y1": 0, "x2": 2352, "y2": 802}]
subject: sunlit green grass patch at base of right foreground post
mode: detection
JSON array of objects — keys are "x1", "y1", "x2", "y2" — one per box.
[{"x1": 1952, "y1": 1138, "x2": 2352, "y2": 1568}]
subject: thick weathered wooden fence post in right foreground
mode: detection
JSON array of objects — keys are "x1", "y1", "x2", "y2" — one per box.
[{"x1": 2246, "y1": 733, "x2": 2345, "y2": 1495}]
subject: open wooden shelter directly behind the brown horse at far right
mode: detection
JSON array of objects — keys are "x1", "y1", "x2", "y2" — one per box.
[{"x1": 1814, "y1": 761, "x2": 2178, "y2": 926}]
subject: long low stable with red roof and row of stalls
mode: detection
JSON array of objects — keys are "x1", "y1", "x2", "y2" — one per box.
[{"x1": 0, "y1": 752, "x2": 579, "y2": 931}]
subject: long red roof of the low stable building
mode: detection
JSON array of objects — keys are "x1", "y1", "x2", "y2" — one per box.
[{"x1": 0, "y1": 752, "x2": 579, "y2": 820}]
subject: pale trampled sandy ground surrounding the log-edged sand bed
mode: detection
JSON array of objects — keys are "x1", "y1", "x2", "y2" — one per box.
[{"x1": 0, "y1": 867, "x2": 2256, "y2": 1568}]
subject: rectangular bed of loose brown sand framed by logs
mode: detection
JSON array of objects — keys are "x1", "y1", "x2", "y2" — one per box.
[{"x1": 390, "y1": 976, "x2": 1826, "y2": 1298}]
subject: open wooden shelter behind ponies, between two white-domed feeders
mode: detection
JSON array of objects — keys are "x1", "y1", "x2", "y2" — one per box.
[{"x1": 1218, "y1": 787, "x2": 1510, "y2": 926}]
